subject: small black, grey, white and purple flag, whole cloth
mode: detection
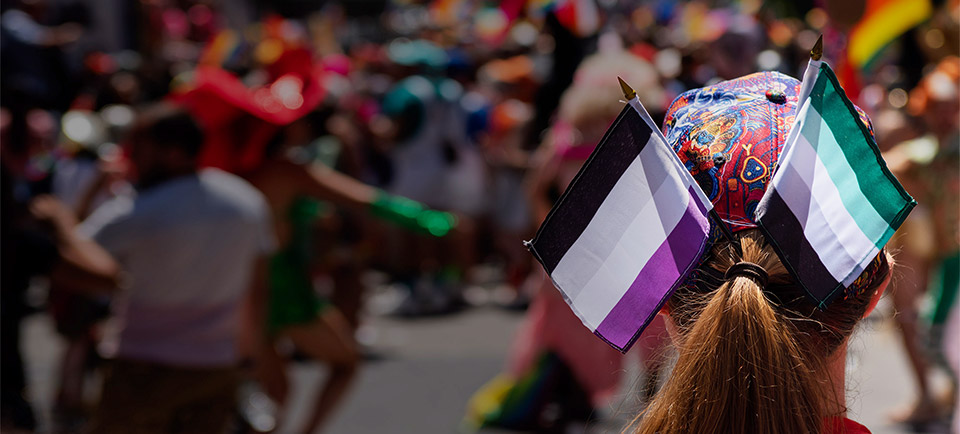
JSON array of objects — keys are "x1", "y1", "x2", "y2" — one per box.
[{"x1": 527, "y1": 98, "x2": 712, "y2": 352}]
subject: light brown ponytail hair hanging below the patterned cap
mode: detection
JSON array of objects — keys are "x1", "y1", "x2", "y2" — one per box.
[{"x1": 634, "y1": 230, "x2": 884, "y2": 434}]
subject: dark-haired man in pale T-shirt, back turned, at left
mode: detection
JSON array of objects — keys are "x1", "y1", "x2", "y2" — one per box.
[{"x1": 31, "y1": 104, "x2": 275, "y2": 433}]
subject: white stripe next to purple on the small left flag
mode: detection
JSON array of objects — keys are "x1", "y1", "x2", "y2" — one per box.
[{"x1": 554, "y1": 169, "x2": 690, "y2": 331}]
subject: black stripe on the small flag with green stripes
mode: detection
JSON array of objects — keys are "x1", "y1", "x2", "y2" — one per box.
[{"x1": 757, "y1": 192, "x2": 843, "y2": 307}]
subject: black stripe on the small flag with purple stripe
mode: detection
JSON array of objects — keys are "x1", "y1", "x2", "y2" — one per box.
[{"x1": 533, "y1": 105, "x2": 652, "y2": 274}]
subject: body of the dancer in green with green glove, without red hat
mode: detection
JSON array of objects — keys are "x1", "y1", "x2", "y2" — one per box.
[{"x1": 247, "y1": 115, "x2": 456, "y2": 432}]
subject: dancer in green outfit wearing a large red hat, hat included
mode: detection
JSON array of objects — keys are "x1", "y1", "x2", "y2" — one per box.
[{"x1": 174, "y1": 41, "x2": 457, "y2": 432}]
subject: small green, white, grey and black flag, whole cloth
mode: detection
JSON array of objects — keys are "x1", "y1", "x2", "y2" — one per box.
[{"x1": 756, "y1": 62, "x2": 916, "y2": 306}]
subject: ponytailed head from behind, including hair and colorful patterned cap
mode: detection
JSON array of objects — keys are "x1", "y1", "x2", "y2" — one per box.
[{"x1": 636, "y1": 73, "x2": 890, "y2": 434}]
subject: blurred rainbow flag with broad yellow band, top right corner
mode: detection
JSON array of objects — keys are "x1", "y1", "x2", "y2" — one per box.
[{"x1": 847, "y1": 0, "x2": 933, "y2": 69}]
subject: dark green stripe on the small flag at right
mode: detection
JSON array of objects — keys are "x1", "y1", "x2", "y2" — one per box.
[{"x1": 808, "y1": 63, "x2": 915, "y2": 231}]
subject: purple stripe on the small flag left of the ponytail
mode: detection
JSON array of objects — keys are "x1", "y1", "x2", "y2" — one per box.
[{"x1": 595, "y1": 187, "x2": 710, "y2": 351}]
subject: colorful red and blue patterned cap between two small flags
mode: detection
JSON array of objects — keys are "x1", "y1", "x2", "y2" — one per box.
[{"x1": 663, "y1": 72, "x2": 886, "y2": 295}]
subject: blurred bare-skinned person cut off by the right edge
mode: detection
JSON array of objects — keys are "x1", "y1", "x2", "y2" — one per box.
[{"x1": 884, "y1": 56, "x2": 960, "y2": 428}]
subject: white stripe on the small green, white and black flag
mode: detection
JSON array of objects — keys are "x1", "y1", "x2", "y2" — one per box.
[{"x1": 773, "y1": 122, "x2": 879, "y2": 285}]
